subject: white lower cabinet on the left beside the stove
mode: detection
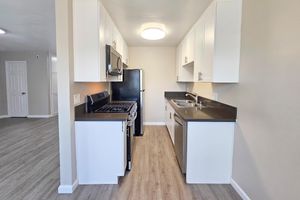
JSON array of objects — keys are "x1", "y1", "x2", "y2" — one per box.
[{"x1": 75, "y1": 121, "x2": 127, "y2": 184}]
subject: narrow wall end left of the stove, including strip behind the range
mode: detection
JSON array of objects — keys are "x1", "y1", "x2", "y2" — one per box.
[{"x1": 55, "y1": 0, "x2": 107, "y2": 193}]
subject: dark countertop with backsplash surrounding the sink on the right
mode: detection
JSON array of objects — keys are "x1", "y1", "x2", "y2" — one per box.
[{"x1": 165, "y1": 92, "x2": 237, "y2": 122}]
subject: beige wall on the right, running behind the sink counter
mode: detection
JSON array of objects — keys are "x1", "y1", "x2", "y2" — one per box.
[{"x1": 189, "y1": 0, "x2": 300, "y2": 200}]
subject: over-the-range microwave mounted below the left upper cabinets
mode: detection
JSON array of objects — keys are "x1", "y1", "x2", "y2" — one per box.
[{"x1": 106, "y1": 45, "x2": 123, "y2": 76}]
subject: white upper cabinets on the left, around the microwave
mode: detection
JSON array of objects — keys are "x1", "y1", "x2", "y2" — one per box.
[{"x1": 73, "y1": 0, "x2": 128, "y2": 82}]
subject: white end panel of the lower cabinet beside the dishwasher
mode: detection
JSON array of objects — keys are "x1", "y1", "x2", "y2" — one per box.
[{"x1": 186, "y1": 122, "x2": 235, "y2": 184}]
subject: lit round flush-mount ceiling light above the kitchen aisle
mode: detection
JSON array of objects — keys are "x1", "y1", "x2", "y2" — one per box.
[{"x1": 141, "y1": 23, "x2": 166, "y2": 40}]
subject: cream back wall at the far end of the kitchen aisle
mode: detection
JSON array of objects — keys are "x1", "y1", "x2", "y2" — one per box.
[{"x1": 129, "y1": 47, "x2": 186, "y2": 123}]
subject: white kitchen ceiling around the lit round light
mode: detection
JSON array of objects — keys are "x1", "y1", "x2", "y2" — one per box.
[{"x1": 102, "y1": 0, "x2": 212, "y2": 46}]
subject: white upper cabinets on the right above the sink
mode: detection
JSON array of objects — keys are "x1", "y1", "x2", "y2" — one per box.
[{"x1": 177, "y1": 0, "x2": 242, "y2": 83}]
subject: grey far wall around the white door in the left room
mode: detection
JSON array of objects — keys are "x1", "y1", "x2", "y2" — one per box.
[{"x1": 0, "y1": 52, "x2": 50, "y2": 115}]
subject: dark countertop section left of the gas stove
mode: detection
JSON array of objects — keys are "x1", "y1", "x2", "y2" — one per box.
[{"x1": 75, "y1": 101, "x2": 134, "y2": 121}]
